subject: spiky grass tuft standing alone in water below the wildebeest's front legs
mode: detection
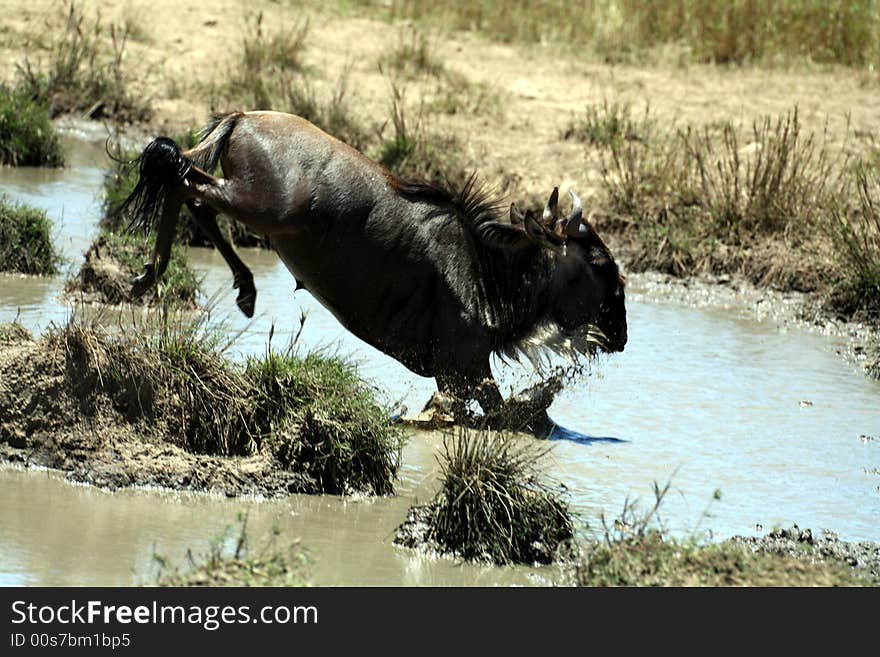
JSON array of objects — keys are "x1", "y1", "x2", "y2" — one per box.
[{"x1": 396, "y1": 430, "x2": 574, "y2": 564}]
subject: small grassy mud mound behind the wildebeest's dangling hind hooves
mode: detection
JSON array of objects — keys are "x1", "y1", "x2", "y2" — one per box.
[{"x1": 64, "y1": 232, "x2": 199, "y2": 309}]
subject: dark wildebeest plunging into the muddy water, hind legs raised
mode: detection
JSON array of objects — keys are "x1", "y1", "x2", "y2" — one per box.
[{"x1": 124, "y1": 111, "x2": 627, "y2": 434}]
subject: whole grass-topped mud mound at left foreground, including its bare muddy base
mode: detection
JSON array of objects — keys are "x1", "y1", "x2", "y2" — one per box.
[{"x1": 0, "y1": 325, "x2": 401, "y2": 496}]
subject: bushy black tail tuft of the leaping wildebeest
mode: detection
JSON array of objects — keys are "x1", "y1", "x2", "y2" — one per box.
[{"x1": 117, "y1": 137, "x2": 193, "y2": 233}]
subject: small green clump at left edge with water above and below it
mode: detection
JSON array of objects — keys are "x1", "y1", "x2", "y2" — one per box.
[{"x1": 0, "y1": 195, "x2": 60, "y2": 276}]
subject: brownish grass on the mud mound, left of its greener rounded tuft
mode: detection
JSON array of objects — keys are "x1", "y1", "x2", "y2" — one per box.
[{"x1": 49, "y1": 313, "x2": 257, "y2": 456}]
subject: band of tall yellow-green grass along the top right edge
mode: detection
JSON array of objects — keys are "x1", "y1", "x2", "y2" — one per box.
[{"x1": 384, "y1": 0, "x2": 880, "y2": 66}]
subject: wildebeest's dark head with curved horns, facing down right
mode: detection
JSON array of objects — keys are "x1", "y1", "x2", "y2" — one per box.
[{"x1": 511, "y1": 188, "x2": 627, "y2": 353}]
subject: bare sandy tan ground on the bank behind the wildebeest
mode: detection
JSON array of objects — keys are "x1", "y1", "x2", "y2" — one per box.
[{"x1": 0, "y1": 0, "x2": 880, "y2": 202}]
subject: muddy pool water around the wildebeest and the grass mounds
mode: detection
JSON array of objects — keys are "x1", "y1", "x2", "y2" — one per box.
[{"x1": 0, "y1": 133, "x2": 880, "y2": 585}]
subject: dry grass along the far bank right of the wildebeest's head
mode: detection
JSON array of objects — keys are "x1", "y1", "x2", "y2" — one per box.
[{"x1": 584, "y1": 105, "x2": 880, "y2": 322}]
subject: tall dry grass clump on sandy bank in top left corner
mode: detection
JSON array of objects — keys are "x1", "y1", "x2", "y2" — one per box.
[{"x1": 17, "y1": 2, "x2": 152, "y2": 122}]
